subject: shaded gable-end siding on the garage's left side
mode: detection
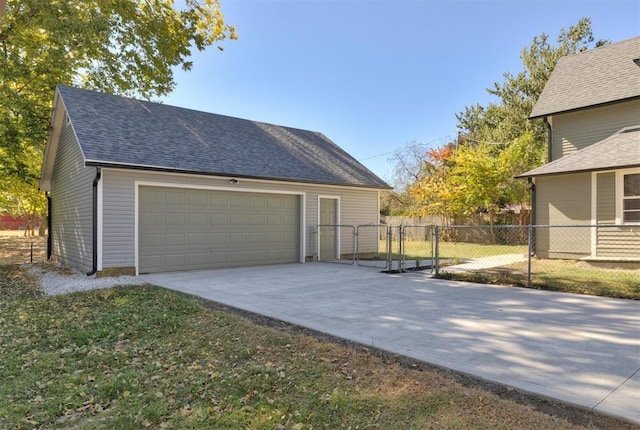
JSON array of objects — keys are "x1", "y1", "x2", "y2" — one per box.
[{"x1": 50, "y1": 124, "x2": 96, "y2": 271}]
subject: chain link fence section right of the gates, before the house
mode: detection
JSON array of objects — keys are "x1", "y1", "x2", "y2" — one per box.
[{"x1": 435, "y1": 225, "x2": 640, "y2": 296}]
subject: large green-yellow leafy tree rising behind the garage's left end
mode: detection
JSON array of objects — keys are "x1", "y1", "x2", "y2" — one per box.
[{"x1": 0, "y1": 0, "x2": 237, "y2": 232}]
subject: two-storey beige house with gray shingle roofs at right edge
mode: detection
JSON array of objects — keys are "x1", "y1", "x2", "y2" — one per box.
[{"x1": 520, "y1": 37, "x2": 640, "y2": 261}]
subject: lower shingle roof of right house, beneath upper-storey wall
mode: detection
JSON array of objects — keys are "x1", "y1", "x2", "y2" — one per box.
[{"x1": 517, "y1": 125, "x2": 640, "y2": 178}]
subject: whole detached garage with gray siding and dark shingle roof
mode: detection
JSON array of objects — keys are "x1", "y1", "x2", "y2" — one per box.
[{"x1": 40, "y1": 86, "x2": 390, "y2": 276}]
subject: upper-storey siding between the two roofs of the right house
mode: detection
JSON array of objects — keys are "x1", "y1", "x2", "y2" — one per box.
[{"x1": 551, "y1": 100, "x2": 640, "y2": 160}]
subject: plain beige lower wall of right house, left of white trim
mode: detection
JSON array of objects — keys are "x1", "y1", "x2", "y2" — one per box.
[{"x1": 536, "y1": 173, "x2": 591, "y2": 258}]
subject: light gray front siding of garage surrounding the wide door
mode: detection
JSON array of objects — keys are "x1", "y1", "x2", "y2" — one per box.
[{"x1": 102, "y1": 169, "x2": 379, "y2": 269}]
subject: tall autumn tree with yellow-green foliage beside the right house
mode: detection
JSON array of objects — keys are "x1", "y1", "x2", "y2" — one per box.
[{"x1": 411, "y1": 18, "x2": 608, "y2": 225}]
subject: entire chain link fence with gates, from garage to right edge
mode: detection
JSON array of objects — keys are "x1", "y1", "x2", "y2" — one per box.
[{"x1": 314, "y1": 224, "x2": 640, "y2": 298}]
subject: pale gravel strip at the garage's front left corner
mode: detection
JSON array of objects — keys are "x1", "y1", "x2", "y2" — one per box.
[{"x1": 29, "y1": 264, "x2": 146, "y2": 296}]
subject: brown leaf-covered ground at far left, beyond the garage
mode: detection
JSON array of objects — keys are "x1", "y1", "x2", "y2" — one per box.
[{"x1": 0, "y1": 230, "x2": 47, "y2": 264}]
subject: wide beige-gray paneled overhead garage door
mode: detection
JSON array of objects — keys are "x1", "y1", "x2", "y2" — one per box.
[{"x1": 138, "y1": 186, "x2": 300, "y2": 273}]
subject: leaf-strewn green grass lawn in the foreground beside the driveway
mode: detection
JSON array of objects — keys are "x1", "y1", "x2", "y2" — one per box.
[{"x1": 0, "y1": 266, "x2": 633, "y2": 430}]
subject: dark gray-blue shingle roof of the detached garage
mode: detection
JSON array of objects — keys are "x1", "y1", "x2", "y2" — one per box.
[{"x1": 58, "y1": 85, "x2": 389, "y2": 188}]
